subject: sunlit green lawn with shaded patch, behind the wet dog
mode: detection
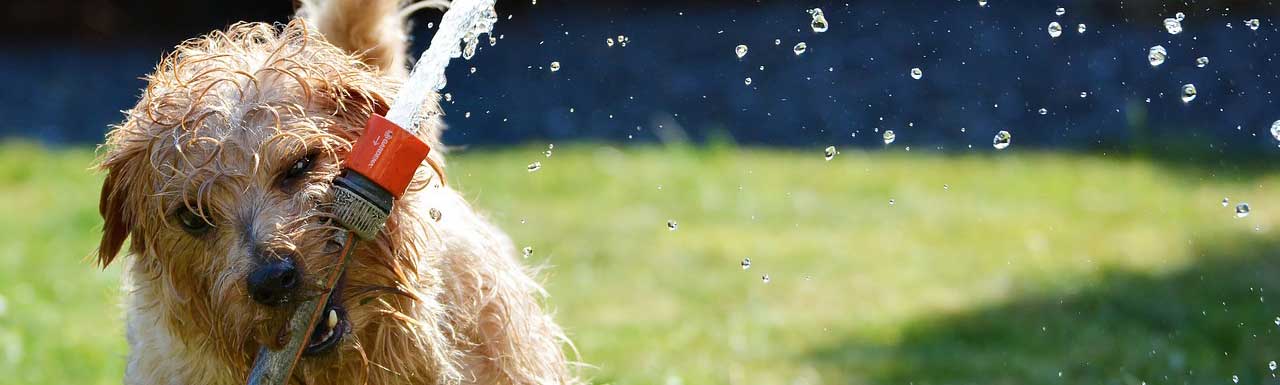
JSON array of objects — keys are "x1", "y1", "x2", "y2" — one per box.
[{"x1": 0, "y1": 143, "x2": 1280, "y2": 384}]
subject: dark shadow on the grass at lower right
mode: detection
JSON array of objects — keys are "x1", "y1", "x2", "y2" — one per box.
[{"x1": 804, "y1": 240, "x2": 1280, "y2": 385}]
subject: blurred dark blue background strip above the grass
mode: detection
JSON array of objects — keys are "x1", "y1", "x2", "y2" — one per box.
[{"x1": 0, "y1": 0, "x2": 1280, "y2": 155}]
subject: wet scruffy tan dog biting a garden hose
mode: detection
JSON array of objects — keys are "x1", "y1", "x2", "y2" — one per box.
[{"x1": 99, "y1": 0, "x2": 577, "y2": 384}]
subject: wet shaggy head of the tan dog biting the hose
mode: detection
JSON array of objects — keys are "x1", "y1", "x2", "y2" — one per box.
[{"x1": 99, "y1": 22, "x2": 438, "y2": 372}]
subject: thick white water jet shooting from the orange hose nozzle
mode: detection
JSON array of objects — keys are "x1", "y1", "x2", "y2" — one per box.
[{"x1": 387, "y1": 0, "x2": 498, "y2": 132}]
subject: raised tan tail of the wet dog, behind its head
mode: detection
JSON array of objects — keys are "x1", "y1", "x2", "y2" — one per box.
[{"x1": 297, "y1": 0, "x2": 449, "y2": 75}]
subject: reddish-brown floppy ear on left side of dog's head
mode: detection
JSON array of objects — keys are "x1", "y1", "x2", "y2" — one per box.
[{"x1": 97, "y1": 156, "x2": 132, "y2": 269}]
